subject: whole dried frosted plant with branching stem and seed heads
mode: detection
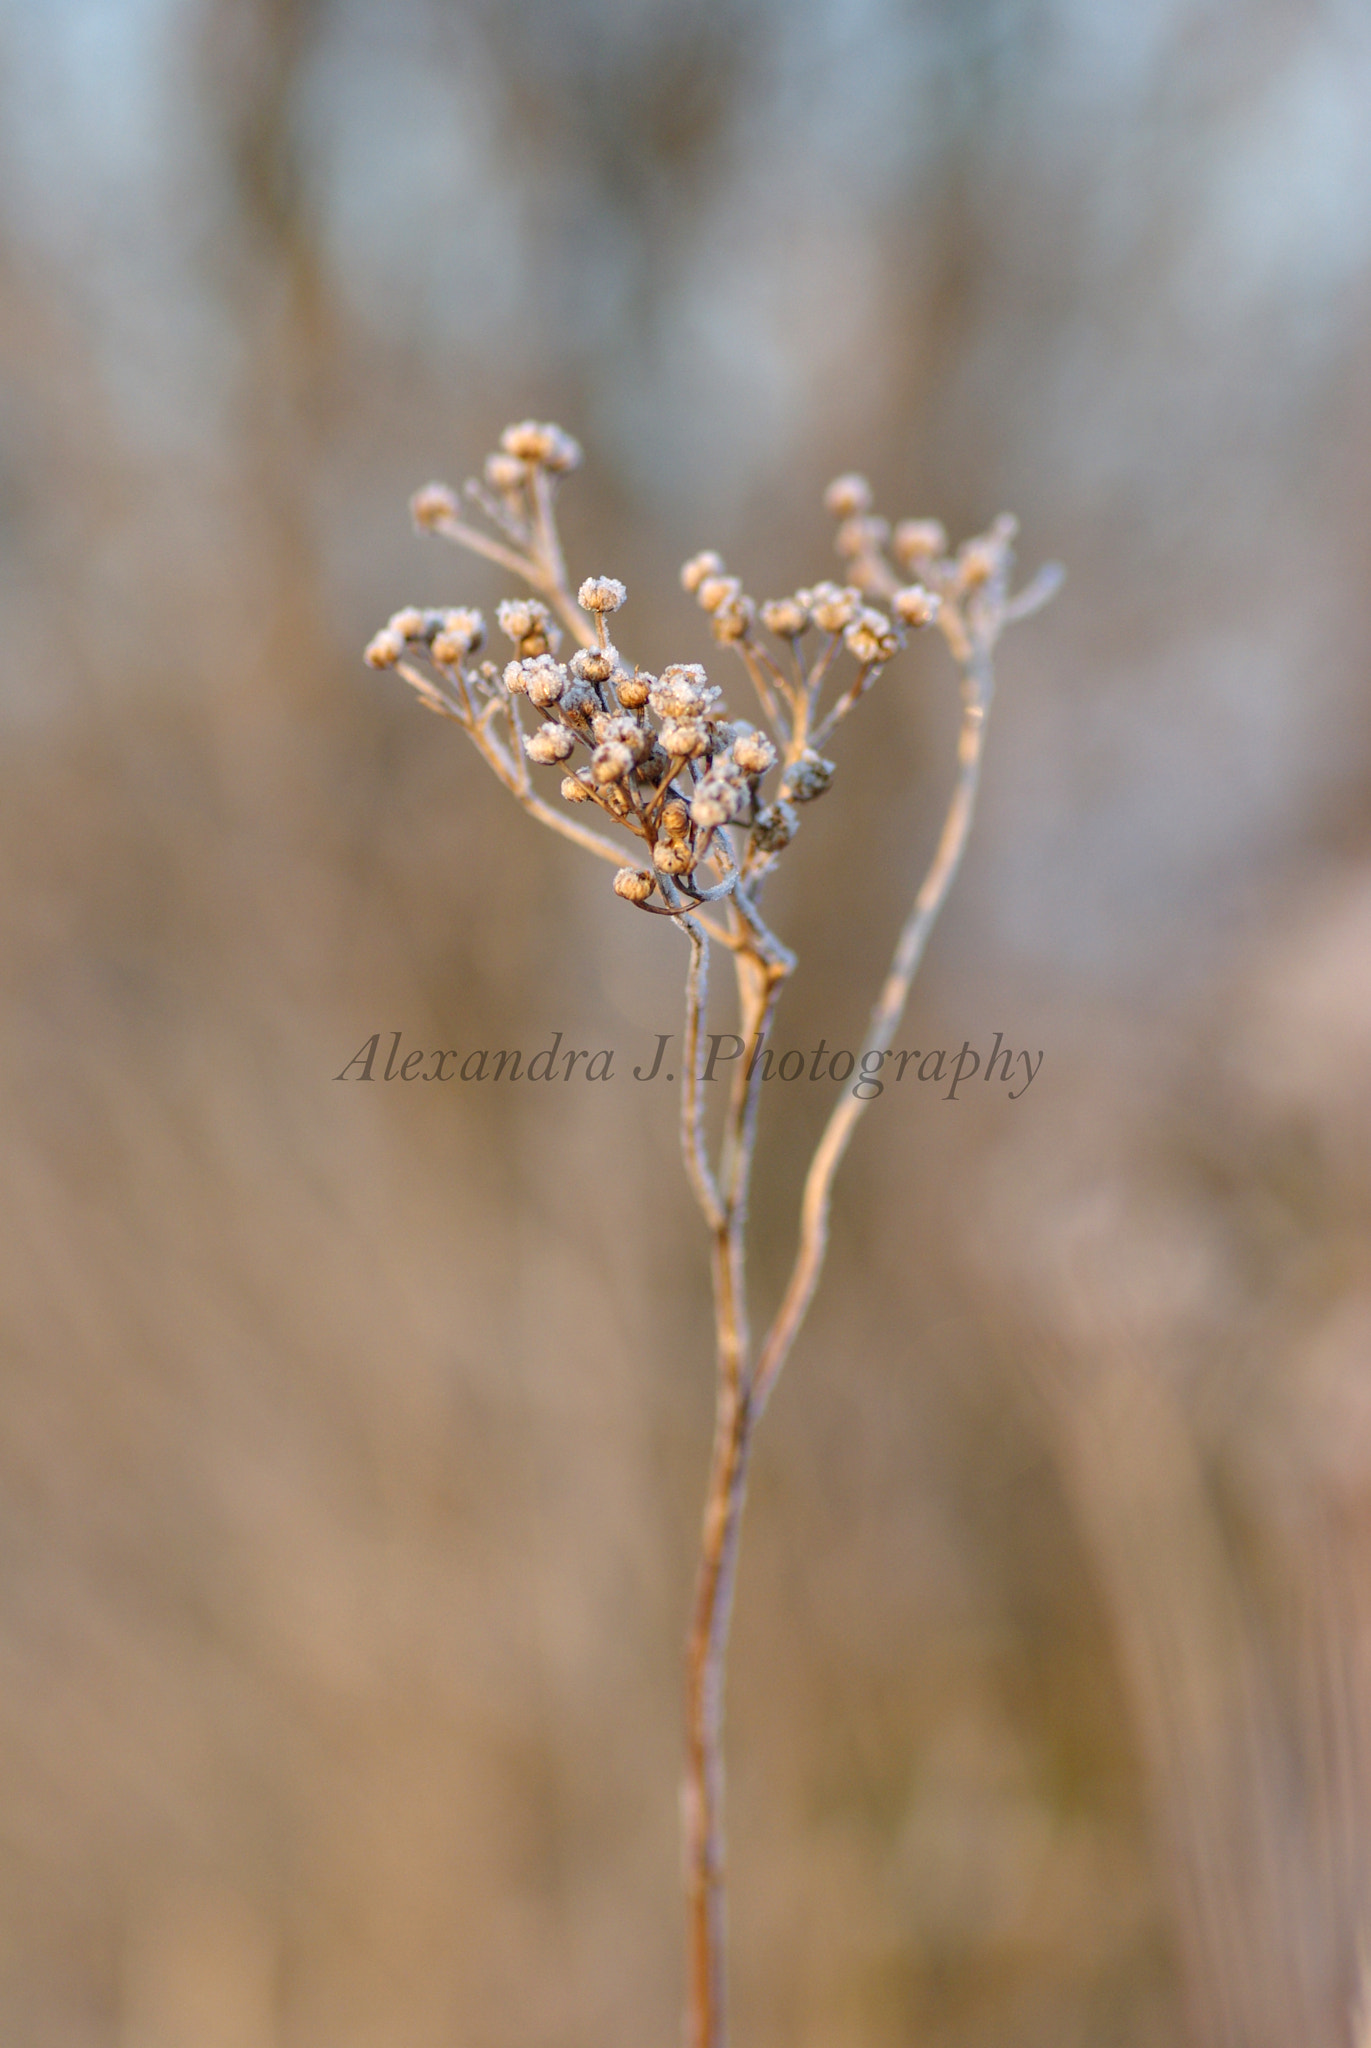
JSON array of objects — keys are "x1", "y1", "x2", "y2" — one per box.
[{"x1": 367, "y1": 420, "x2": 1060, "y2": 2048}]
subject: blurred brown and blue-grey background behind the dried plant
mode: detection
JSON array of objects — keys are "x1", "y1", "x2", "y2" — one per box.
[{"x1": 0, "y1": 0, "x2": 1371, "y2": 2048}]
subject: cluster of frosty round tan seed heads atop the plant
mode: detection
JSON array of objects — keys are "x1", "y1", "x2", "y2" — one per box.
[{"x1": 367, "y1": 420, "x2": 1049, "y2": 915}]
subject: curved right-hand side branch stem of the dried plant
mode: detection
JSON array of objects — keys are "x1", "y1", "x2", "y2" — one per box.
[{"x1": 750, "y1": 653, "x2": 994, "y2": 1415}]
